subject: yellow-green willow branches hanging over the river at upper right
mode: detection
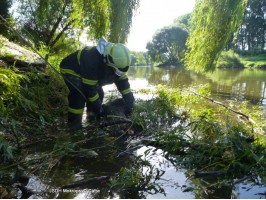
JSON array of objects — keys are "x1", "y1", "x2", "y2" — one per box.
[{"x1": 185, "y1": 0, "x2": 247, "y2": 71}]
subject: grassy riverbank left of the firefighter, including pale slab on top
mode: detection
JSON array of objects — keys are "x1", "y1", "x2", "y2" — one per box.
[{"x1": 0, "y1": 36, "x2": 67, "y2": 162}]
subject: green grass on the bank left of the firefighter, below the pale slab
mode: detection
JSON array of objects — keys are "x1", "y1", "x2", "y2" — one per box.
[{"x1": 0, "y1": 63, "x2": 66, "y2": 161}]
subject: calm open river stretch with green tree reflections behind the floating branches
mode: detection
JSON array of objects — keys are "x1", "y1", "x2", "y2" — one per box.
[{"x1": 128, "y1": 67, "x2": 266, "y2": 110}]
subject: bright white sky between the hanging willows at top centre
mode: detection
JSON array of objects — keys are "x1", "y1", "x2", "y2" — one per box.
[{"x1": 127, "y1": 0, "x2": 195, "y2": 51}]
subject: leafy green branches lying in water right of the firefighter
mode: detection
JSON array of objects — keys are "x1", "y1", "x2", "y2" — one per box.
[{"x1": 130, "y1": 86, "x2": 266, "y2": 181}]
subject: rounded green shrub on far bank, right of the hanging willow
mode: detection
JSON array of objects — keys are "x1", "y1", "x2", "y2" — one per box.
[{"x1": 216, "y1": 50, "x2": 244, "y2": 68}]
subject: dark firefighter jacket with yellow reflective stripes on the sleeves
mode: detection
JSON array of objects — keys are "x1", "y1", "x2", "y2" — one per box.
[{"x1": 60, "y1": 47, "x2": 134, "y2": 114}]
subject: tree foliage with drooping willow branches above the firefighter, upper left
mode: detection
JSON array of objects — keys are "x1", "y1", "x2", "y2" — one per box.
[{"x1": 14, "y1": 0, "x2": 138, "y2": 56}]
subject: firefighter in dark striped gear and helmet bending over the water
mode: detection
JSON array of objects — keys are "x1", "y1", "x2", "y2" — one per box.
[{"x1": 60, "y1": 38, "x2": 135, "y2": 128}]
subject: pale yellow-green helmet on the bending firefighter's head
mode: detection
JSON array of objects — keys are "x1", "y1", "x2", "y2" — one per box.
[{"x1": 104, "y1": 43, "x2": 131, "y2": 76}]
